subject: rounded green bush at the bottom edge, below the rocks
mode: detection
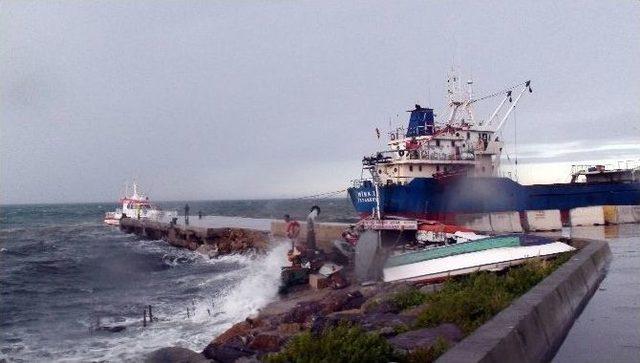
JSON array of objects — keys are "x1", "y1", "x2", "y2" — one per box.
[{"x1": 265, "y1": 324, "x2": 397, "y2": 363}]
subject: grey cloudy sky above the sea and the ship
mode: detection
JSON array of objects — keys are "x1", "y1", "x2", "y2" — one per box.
[{"x1": 0, "y1": 1, "x2": 640, "y2": 203}]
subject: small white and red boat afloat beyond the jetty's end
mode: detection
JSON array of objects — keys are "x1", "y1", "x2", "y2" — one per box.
[{"x1": 104, "y1": 182, "x2": 178, "y2": 225}]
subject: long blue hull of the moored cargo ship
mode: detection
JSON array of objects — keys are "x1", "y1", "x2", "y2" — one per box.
[{"x1": 348, "y1": 177, "x2": 640, "y2": 221}]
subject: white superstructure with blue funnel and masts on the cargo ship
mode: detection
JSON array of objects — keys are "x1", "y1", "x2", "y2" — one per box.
[{"x1": 363, "y1": 72, "x2": 531, "y2": 185}]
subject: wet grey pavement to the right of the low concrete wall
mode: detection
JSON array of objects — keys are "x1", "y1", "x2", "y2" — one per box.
[{"x1": 553, "y1": 224, "x2": 640, "y2": 363}]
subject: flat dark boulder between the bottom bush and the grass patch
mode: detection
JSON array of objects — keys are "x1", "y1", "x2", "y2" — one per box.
[{"x1": 389, "y1": 324, "x2": 463, "y2": 351}]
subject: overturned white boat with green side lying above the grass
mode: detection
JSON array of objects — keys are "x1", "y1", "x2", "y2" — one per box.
[{"x1": 383, "y1": 235, "x2": 575, "y2": 282}]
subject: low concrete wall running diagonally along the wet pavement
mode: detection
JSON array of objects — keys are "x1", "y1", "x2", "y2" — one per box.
[{"x1": 437, "y1": 240, "x2": 611, "y2": 363}]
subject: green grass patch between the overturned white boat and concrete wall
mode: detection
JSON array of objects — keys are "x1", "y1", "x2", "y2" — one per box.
[{"x1": 416, "y1": 253, "x2": 572, "y2": 334}]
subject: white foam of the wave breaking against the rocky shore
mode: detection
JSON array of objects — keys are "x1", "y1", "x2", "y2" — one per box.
[{"x1": 70, "y1": 239, "x2": 288, "y2": 361}]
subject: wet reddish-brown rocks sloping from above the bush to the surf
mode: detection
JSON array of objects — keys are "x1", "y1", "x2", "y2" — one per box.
[{"x1": 203, "y1": 284, "x2": 463, "y2": 362}]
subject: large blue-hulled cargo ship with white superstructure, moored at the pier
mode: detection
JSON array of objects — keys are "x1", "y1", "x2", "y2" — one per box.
[{"x1": 348, "y1": 72, "x2": 640, "y2": 225}]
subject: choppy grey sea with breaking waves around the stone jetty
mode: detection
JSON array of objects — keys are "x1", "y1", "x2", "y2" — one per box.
[{"x1": 0, "y1": 199, "x2": 355, "y2": 362}]
